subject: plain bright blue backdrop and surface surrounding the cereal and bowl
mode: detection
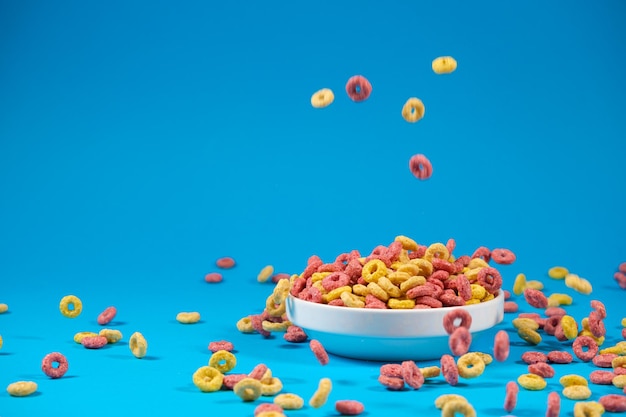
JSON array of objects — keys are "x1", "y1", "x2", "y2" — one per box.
[{"x1": 0, "y1": 0, "x2": 626, "y2": 417}]
